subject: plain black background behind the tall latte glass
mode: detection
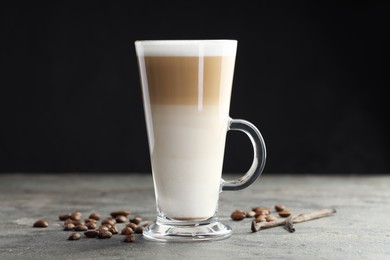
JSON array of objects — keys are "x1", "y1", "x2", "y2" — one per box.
[{"x1": 0, "y1": 1, "x2": 390, "y2": 173}]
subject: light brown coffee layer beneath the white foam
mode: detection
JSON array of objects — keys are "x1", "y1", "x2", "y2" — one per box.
[{"x1": 142, "y1": 56, "x2": 235, "y2": 105}]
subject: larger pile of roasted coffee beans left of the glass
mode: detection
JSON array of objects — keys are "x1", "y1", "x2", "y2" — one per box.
[{"x1": 33, "y1": 210, "x2": 150, "y2": 242}]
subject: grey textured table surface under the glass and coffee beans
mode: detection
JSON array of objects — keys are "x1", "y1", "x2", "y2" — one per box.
[{"x1": 0, "y1": 173, "x2": 390, "y2": 259}]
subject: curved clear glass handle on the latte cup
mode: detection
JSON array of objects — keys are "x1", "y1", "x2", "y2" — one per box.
[{"x1": 222, "y1": 119, "x2": 267, "y2": 191}]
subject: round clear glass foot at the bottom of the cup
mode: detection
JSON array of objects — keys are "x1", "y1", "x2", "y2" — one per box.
[{"x1": 143, "y1": 215, "x2": 232, "y2": 242}]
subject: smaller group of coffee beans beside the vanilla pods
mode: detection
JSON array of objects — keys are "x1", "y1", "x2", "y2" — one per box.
[{"x1": 230, "y1": 204, "x2": 291, "y2": 222}]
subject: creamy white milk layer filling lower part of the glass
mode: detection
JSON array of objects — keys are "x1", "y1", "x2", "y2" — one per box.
[{"x1": 147, "y1": 105, "x2": 229, "y2": 219}]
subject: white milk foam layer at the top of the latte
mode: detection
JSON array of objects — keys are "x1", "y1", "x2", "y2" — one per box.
[{"x1": 135, "y1": 40, "x2": 237, "y2": 56}]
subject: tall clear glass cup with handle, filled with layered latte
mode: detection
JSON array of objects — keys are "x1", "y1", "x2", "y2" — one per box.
[{"x1": 135, "y1": 40, "x2": 266, "y2": 241}]
